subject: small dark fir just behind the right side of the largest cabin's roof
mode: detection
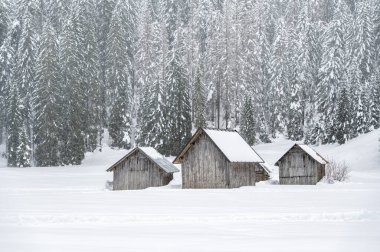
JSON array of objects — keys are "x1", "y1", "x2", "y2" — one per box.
[{"x1": 240, "y1": 96, "x2": 256, "y2": 145}]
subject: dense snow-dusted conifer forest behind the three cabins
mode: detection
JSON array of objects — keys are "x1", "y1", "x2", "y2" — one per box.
[{"x1": 0, "y1": 0, "x2": 380, "y2": 167}]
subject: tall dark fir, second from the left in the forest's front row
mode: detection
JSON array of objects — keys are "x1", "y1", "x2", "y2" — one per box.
[{"x1": 33, "y1": 24, "x2": 64, "y2": 166}]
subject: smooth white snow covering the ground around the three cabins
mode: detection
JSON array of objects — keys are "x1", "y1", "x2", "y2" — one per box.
[{"x1": 0, "y1": 130, "x2": 380, "y2": 252}]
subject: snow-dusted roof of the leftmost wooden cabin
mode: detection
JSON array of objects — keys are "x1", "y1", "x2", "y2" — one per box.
[{"x1": 107, "y1": 147, "x2": 179, "y2": 173}]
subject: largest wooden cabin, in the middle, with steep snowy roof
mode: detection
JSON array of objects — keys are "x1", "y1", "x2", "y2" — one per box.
[{"x1": 174, "y1": 128, "x2": 264, "y2": 188}]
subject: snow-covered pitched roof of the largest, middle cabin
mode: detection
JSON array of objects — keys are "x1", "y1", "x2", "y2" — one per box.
[{"x1": 173, "y1": 128, "x2": 264, "y2": 164}]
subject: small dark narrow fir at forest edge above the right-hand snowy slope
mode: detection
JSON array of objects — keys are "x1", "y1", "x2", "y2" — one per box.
[{"x1": 336, "y1": 87, "x2": 350, "y2": 144}]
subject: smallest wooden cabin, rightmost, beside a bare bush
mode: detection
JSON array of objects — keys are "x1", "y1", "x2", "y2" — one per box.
[{"x1": 275, "y1": 144, "x2": 328, "y2": 185}]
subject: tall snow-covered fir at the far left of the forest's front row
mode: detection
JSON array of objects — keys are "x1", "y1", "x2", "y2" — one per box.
[{"x1": 3, "y1": 1, "x2": 35, "y2": 167}]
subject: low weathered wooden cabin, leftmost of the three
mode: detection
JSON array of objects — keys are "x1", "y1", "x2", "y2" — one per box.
[{"x1": 107, "y1": 147, "x2": 179, "y2": 190}]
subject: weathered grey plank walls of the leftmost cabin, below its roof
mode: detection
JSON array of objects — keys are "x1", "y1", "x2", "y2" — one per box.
[{"x1": 113, "y1": 151, "x2": 173, "y2": 190}]
